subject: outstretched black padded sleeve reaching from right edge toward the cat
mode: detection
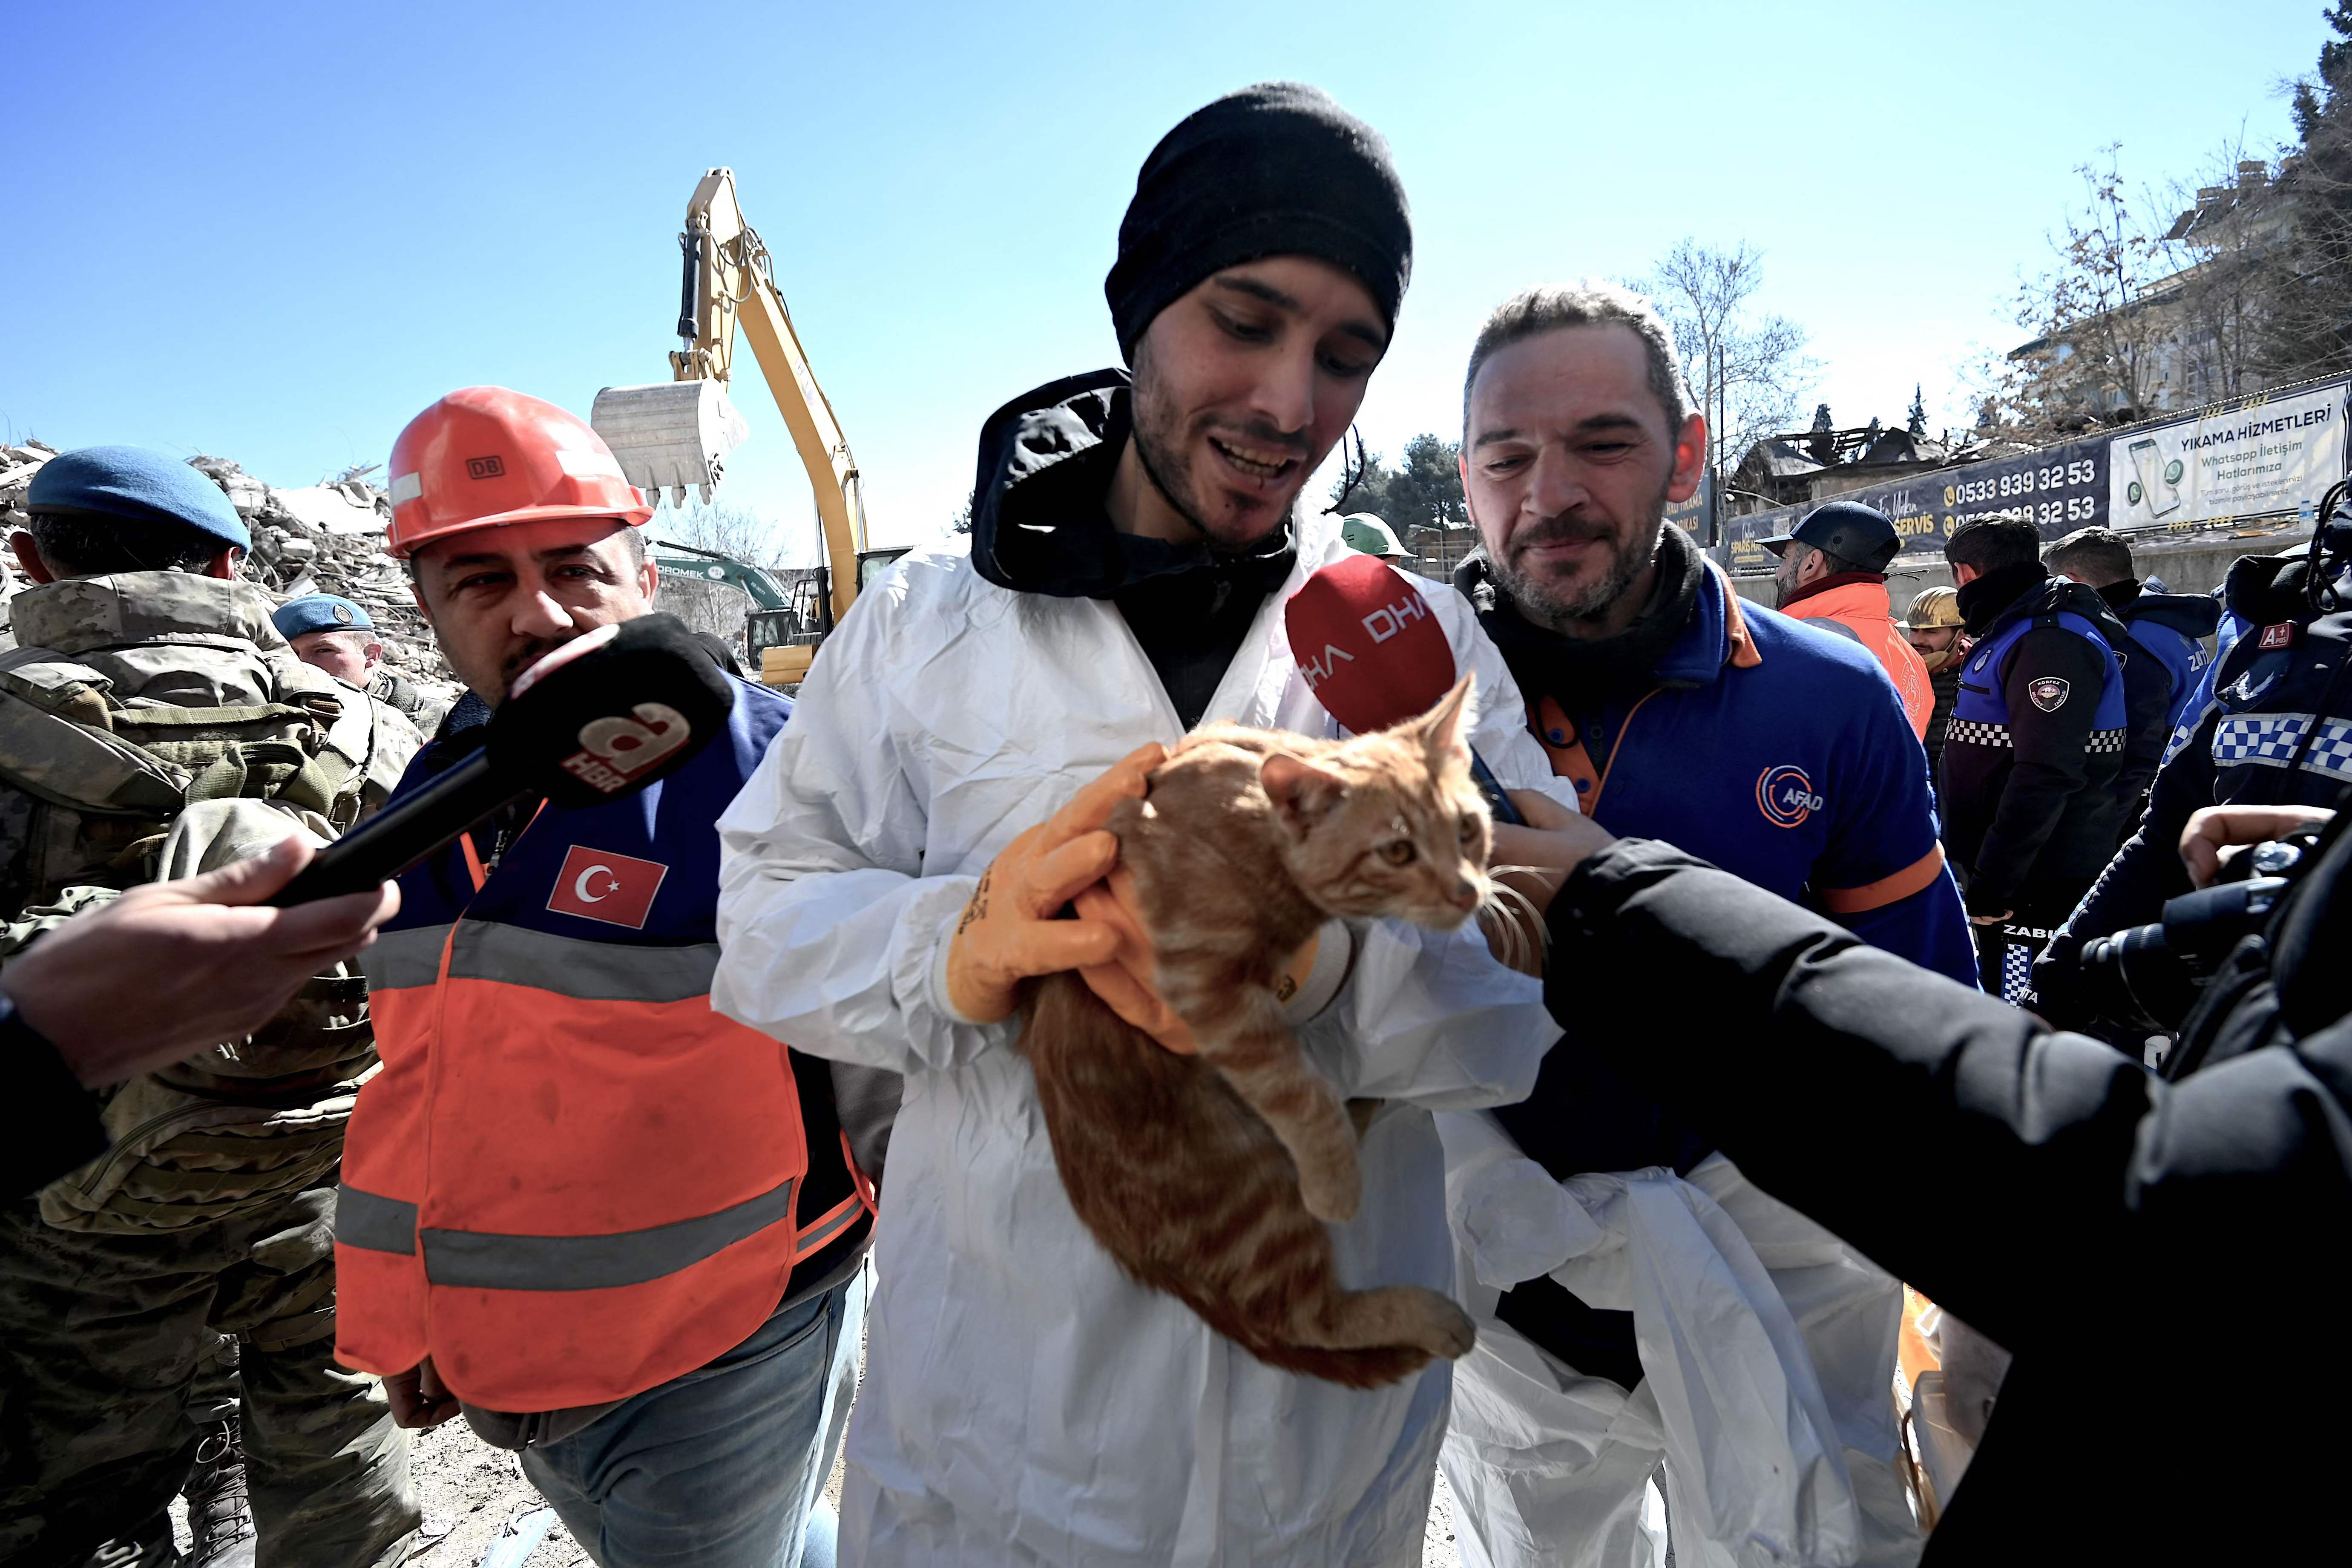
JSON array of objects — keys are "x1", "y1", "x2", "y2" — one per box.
[{"x1": 1547, "y1": 842, "x2": 2352, "y2": 1349}]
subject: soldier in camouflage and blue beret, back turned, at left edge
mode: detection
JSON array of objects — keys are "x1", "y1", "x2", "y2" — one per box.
[{"x1": 0, "y1": 447, "x2": 419, "y2": 1568}]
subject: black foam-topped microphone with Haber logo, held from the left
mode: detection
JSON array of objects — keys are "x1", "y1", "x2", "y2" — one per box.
[{"x1": 266, "y1": 616, "x2": 734, "y2": 907}]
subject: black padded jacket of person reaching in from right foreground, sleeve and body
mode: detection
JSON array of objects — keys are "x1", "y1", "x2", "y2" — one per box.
[{"x1": 1547, "y1": 839, "x2": 2352, "y2": 1565}]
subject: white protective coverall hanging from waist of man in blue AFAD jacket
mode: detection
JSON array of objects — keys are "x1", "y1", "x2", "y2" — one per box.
[{"x1": 1437, "y1": 1114, "x2": 1921, "y2": 1568}]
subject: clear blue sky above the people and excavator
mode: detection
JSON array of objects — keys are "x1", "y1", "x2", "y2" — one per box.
[{"x1": 0, "y1": 0, "x2": 2324, "y2": 555}]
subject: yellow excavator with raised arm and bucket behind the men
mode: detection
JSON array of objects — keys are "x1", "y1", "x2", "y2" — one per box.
[{"x1": 588, "y1": 169, "x2": 906, "y2": 686}]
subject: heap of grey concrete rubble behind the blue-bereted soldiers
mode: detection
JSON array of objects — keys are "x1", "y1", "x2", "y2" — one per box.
[{"x1": 0, "y1": 442, "x2": 461, "y2": 703}]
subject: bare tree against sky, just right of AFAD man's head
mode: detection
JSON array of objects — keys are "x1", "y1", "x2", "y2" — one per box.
[{"x1": 1630, "y1": 240, "x2": 1820, "y2": 470}]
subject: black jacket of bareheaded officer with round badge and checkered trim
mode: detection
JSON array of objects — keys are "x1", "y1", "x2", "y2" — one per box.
[{"x1": 1938, "y1": 567, "x2": 2128, "y2": 915}]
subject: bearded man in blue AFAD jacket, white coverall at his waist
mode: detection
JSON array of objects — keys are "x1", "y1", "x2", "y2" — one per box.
[{"x1": 1442, "y1": 282, "x2": 1975, "y2": 1563}]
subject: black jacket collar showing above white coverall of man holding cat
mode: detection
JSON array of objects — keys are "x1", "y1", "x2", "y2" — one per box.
[{"x1": 972, "y1": 369, "x2": 1298, "y2": 729}]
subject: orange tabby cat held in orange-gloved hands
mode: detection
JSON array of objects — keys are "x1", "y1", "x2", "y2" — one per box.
[{"x1": 1021, "y1": 677, "x2": 1489, "y2": 1387}]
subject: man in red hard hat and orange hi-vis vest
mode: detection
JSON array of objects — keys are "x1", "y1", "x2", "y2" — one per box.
[{"x1": 334, "y1": 388, "x2": 896, "y2": 1568}]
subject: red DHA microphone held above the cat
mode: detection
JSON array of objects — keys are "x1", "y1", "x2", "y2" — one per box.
[{"x1": 1282, "y1": 555, "x2": 1527, "y2": 825}]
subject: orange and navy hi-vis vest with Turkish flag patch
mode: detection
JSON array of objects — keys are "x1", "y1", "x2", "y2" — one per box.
[{"x1": 334, "y1": 693, "x2": 870, "y2": 1413}]
